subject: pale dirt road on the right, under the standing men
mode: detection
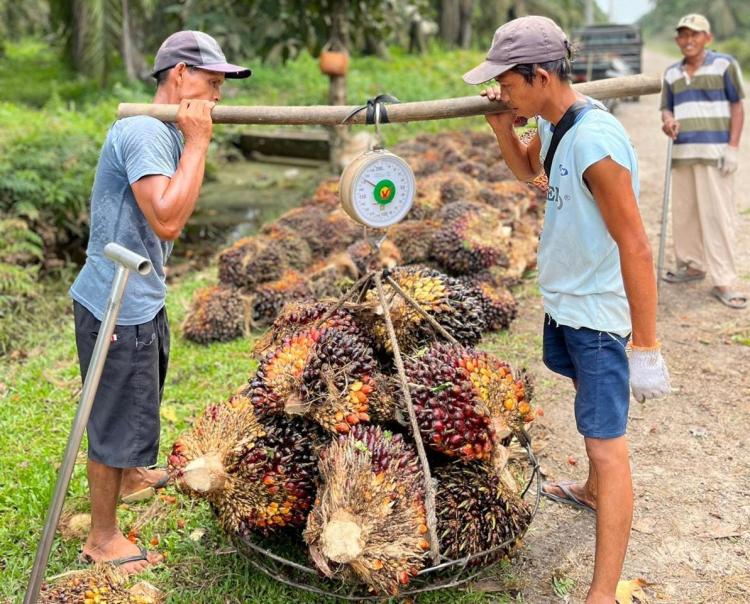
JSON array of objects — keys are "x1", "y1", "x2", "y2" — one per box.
[{"x1": 513, "y1": 52, "x2": 750, "y2": 604}]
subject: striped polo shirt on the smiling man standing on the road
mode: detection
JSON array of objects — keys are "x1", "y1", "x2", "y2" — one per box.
[{"x1": 661, "y1": 50, "x2": 745, "y2": 166}]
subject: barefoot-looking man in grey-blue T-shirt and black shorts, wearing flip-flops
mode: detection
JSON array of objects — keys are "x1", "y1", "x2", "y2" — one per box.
[{"x1": 70, "y1": 31, "x2": 250, "y2": 573}]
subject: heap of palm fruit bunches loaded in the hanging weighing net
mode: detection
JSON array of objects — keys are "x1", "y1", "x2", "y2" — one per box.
[{"x1": 168, "y1": 266, "x2": 539, "y2": 597}]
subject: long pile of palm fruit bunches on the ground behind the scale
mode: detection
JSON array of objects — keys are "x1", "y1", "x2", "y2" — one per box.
[{"x1": 183, "y1": 133, "x2": 542, "y2": 343}]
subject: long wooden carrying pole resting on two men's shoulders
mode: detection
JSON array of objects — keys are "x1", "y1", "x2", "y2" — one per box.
[{"x1": 117, "y1": 74, "x2": 661, "y2": 126}]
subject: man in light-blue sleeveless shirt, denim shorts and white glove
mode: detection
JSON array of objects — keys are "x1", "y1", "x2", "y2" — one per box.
[{"x1": 464, "y1": 16, "x2": 669, "y2": 604}]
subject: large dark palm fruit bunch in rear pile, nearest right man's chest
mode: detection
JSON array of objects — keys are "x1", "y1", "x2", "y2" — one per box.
[{"x1": 431, "y1": 205, "x2": 509, "y2": 275}]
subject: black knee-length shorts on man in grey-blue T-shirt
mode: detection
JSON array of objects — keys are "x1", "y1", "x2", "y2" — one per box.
[{"x1": 73, "y1": 302, "x2": 169, "y2": 468}]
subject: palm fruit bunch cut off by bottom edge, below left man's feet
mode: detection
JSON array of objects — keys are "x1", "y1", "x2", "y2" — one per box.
[{"x1": 38, "y1": 563, "x2": 157, "y2": 604}]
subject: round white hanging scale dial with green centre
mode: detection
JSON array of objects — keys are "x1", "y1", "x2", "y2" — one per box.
[{"x1": 339, "y1": 150, "x2": 416, "y2": 229}]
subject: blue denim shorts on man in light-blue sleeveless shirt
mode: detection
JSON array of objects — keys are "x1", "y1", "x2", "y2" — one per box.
[{"x1": 543, "y1": 315, "x2": 630, "y2": 438}]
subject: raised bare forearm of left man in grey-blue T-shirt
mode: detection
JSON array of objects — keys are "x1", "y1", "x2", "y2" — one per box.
[{"x1": 154, "y1": 144, "x2": 207, "y2": 235}]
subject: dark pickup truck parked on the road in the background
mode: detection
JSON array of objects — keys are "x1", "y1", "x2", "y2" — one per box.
[{"x1": 572, "y1": 23, "x2": 643, "y2": 82}]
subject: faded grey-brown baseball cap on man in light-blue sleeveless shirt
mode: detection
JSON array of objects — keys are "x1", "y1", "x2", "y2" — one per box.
[{"x1": 464, "y1": 16, "x2": 570, "y2": 84}]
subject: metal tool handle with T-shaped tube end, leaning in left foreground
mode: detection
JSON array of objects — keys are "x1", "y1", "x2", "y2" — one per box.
[{"x1": 23, "y1": 243, "x2": 152, "y2": 604}]
